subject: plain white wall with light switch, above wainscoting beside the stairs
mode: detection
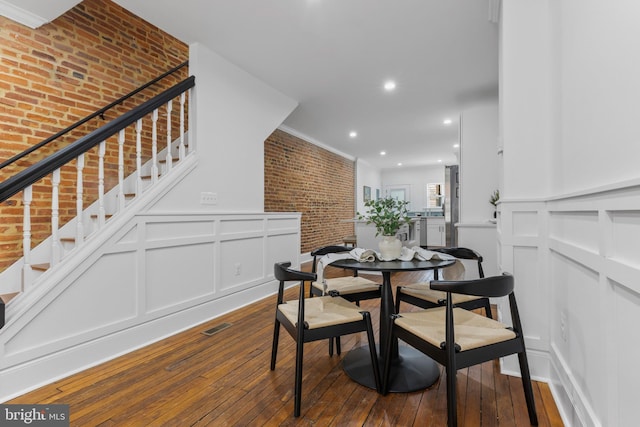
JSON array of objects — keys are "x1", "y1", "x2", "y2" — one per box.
[{"x1": 150, "y1": 43, "x2": 297, "y2": 212}]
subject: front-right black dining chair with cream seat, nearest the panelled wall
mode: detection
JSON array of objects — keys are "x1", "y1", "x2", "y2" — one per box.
[{"x1": 382, "y1": 274, "x2": 538, "y2": 427}]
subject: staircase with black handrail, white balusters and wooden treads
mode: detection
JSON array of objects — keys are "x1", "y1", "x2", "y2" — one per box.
[{"x1": 0, "y1": 73, "x2": 195, "y2": 328}]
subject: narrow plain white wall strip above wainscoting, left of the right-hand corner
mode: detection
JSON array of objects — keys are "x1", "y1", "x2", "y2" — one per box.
[{"x1": 500, "y1": 0, "x2": 557, "y2": 199}]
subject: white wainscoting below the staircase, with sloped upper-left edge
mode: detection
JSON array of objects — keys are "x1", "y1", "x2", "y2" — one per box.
[{"x1": 0, "y1": 211, "x2": 300, "y2": 401}]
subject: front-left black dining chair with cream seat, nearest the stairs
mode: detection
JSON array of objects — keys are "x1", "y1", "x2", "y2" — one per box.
[{"x1": 271, "y1": 262, "x2": 382, "y2": 417}]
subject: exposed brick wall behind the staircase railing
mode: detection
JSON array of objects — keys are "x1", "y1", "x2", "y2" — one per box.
[{"x1": 0, "y1": 0, "x2": 188, "y2": 270}]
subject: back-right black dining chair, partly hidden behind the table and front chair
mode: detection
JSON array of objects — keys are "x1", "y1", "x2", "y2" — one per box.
[{"x1": 396, "y1": 248, "x2": 493, "y2": 318}]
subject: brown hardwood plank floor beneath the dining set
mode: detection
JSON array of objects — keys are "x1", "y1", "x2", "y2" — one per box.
[{"x1": 7, "y1": 269, "x2": 562, "y2": 427}]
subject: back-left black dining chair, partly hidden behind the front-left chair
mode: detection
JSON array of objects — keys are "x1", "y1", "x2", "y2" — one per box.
[{"x1": 309, "y1": 246, "x2": 381, "y2": 356}]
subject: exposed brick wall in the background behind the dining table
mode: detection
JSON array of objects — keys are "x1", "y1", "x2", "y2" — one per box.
[{"x1": 264, "y1": 130, "x2": 355, "y2": 253}]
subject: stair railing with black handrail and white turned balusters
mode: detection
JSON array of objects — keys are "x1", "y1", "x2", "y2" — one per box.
[{"x1": 0, "y1": 76, "x2": 195, "y2": 291}]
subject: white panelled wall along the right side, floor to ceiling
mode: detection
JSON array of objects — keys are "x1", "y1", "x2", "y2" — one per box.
[{"x1": 499, "y1": 0, "x2": 640, "y2": 426}]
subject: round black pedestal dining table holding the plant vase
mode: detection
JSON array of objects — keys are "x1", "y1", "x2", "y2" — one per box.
[{"x1": 331, "y1": 259, "x2": 455, "y2": 392}]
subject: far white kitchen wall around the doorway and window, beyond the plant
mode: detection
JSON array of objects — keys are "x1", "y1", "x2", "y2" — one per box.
[{"x1": 382, "y1": 165, "x2": 444, "y2": 211}]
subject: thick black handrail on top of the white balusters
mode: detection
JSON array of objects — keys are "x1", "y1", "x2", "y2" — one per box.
[{"x1": 0, "y1": 76, "x2": 195, "y2": 203}]
